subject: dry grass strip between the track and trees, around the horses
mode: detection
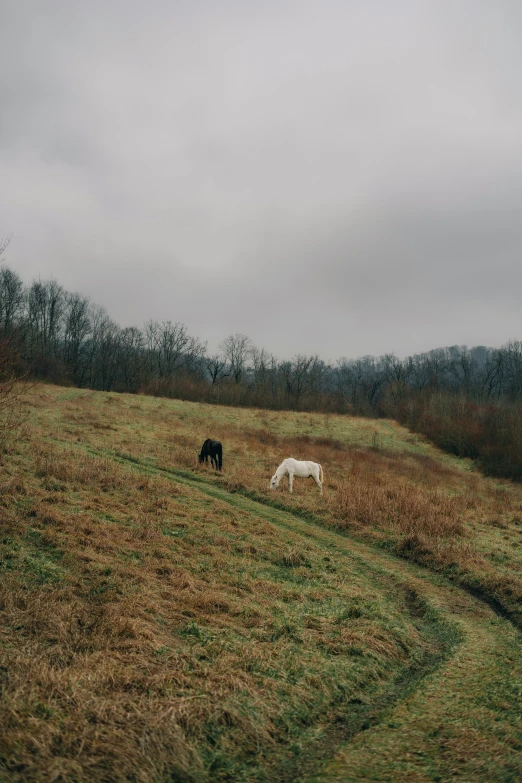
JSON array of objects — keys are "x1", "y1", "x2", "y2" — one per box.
[{"x1": 23, "y1": 387, "x2": 522, "y2": 620}]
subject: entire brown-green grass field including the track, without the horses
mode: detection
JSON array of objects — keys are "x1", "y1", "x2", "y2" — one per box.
[{"x1": 0, "y1": 386, "x2": 522, "y2": 783}]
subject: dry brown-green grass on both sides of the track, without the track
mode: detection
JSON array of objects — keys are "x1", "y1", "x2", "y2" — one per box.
[{"x1": 5, "y1": 387, "x2": 522, "y2": 783}]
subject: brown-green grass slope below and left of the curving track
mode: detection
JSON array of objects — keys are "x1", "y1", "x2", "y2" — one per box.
[{"x1": 0, "y1": 428, "x2": 430, "y2": 783}]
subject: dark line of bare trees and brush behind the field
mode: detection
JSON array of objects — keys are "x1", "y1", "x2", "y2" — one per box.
[{"x1": 0, "y1": 265, "x2": 522, "y2": 478}]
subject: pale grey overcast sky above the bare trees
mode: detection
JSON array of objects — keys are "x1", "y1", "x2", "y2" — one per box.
[{"x1": 0, "y1": 0, "x2": 522, "y2": 359}]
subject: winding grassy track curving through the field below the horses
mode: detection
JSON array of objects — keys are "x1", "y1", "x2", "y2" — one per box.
[{"x1": 62, "y1": 443, "x2": 522, "y2": 783}]
